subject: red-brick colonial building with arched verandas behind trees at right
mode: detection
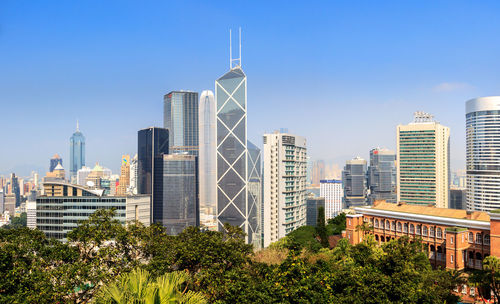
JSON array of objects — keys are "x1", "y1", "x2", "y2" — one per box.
[{"x1": 344, "y1": 201, "x2": 500, "y2": 303}]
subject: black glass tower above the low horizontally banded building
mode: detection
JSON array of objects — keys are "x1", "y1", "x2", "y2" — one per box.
[{"x1": 137, "y1": 127, "x2": 168, "y2": 223}]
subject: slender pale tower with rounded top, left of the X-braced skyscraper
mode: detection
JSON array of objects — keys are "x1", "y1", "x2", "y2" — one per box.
[{"x1": 198, "y1": 91, "x2": 217, "y2": 230}]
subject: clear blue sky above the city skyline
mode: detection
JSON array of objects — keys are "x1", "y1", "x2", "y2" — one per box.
[{"x1": 0, "y1": 0, "x2": 500, "y2": 175}]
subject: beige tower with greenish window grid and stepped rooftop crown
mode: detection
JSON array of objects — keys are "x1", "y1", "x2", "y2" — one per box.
[{"x1": 397, "y1": 112, "x2": 450, "y2": 208}]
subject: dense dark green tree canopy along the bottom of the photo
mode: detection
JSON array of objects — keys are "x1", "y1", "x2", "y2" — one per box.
[{"x1": 0, "y1": 210, "x2": 484, "y2": 303}]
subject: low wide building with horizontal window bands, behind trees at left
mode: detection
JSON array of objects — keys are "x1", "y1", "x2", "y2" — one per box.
[{"x1": 36, "y1": 182, "x2": 150, "y2": 241}]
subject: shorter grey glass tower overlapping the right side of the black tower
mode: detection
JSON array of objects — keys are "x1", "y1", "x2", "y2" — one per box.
[{"x1": 154, "y1": 154, "x2": 199, "y2": 235}]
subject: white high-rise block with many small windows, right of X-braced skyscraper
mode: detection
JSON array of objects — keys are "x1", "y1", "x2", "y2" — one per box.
[{"x1": 263, "y1": 131, "x2": 307, "y2": 247}]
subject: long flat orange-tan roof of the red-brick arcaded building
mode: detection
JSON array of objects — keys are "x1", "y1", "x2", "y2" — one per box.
[{"x1": 372, "y1": 201, "x2": 490, "y2": 222}]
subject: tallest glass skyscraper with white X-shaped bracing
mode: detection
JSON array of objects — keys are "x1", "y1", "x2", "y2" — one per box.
[{"x1": 215, "y1": 33, "x2": 261, "y2": 243}]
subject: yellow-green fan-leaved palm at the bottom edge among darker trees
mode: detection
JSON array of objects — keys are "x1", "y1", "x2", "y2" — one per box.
[{"x1": 96, "y1": 269, "x2": 207, "y2": 304}]
